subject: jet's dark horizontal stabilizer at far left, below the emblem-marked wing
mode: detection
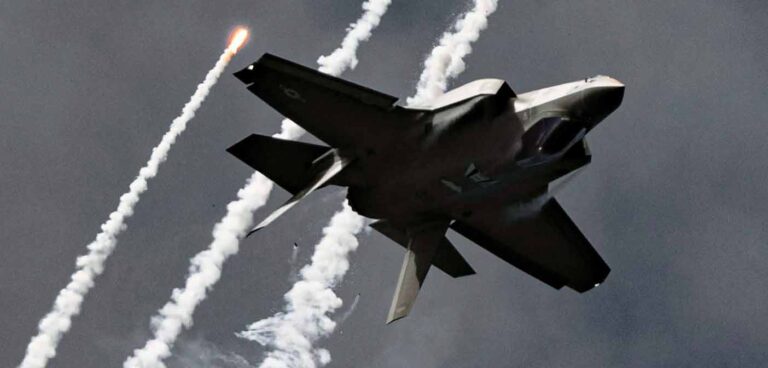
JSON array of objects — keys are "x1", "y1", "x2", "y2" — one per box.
[{"x1": 227, "y1": 134, "x2": 331, "y2": 194}]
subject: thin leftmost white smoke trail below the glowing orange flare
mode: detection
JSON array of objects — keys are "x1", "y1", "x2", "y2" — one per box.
[{"x1": 19, "y1": 41, "x2": 242, "y2": 368}]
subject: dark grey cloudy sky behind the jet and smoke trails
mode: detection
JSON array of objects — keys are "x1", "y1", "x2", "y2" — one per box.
[{"x1": 0, "y1": 0, "x2": 768, "y2": 368}]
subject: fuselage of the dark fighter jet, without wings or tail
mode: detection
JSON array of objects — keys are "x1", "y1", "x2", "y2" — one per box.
[{"x1": 346, "y1": 76, "x2": 624, "y2": 224}]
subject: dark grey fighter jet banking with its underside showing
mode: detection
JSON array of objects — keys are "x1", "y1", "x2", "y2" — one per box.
[{"x1": 228, "y1": 54, "x2": 624, "y2": 323}]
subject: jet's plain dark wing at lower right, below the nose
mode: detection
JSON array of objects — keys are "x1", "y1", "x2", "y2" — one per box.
[{"x1": 451, "y1": 198, "x2": 610, "y2": 292}]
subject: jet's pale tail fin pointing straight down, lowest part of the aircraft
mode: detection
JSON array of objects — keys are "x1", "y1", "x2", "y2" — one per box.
[{"x1": 387, "y1": 222, "x2": 448, "y2": 323}]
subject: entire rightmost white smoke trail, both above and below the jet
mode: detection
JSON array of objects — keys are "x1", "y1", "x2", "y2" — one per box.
[{"x1": 237, "y1": 0, "x2": 497, "y2": 368}]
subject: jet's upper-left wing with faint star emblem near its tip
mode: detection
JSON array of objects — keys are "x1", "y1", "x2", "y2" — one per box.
[{"x1": 235, "y1": 54, "x2": 403, "y2": 150}]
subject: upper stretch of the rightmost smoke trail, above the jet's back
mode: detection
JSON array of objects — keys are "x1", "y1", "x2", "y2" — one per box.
[{"x1": 407, "y1": 0, "x2": 498, "y2": 107}]
